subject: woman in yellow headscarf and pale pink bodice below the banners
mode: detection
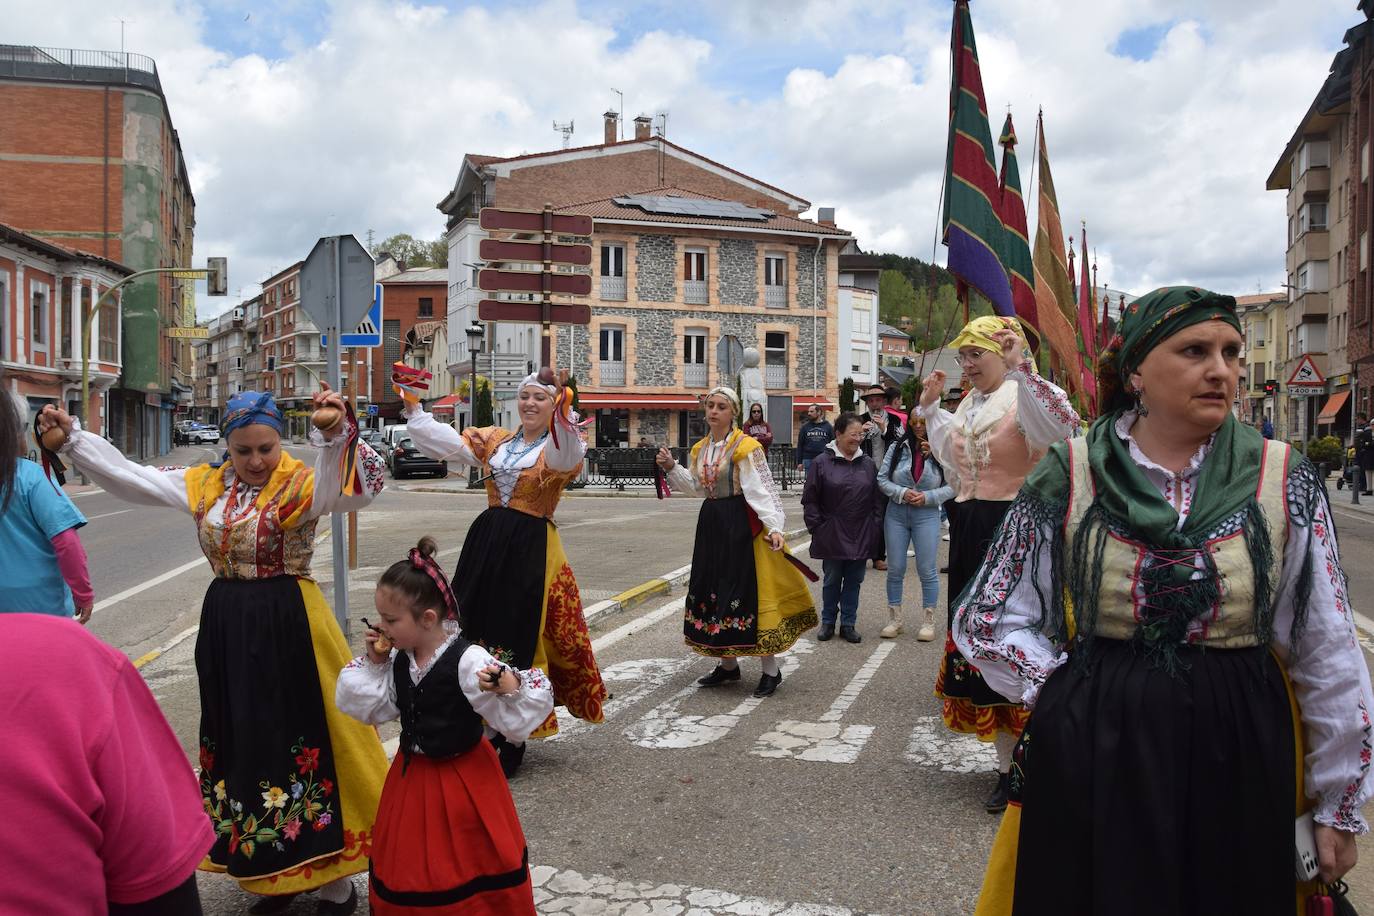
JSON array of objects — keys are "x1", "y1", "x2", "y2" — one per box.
[{"x1": 919, "y1": 316, "x2": 1079, "y2": 813}]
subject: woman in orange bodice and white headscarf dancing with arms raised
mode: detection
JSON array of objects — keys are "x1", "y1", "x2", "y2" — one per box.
[{"x1": 397, "y1": 368, "x2": 607, "y2": 775}]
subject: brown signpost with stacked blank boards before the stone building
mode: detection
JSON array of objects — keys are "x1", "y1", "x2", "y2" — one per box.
[{"x1": 477, "y1": 203, "x2": 592, "y2": 365}]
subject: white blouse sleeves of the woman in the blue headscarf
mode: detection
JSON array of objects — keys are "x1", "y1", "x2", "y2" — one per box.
[{"x1": 60, "y1": 419, "x2": 386, "y2": 526}]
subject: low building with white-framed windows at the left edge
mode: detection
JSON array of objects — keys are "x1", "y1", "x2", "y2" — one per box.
[{"x1": 0, "y1": 225, "x2": 132, "y2": 433}]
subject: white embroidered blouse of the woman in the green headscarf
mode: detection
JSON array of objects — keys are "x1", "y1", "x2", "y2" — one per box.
[{"x1": 954, "y1": 413, "x2": 1374, "y2": 834}]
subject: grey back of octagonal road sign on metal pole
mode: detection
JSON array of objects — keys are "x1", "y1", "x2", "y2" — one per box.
[{"x1": 300, "y1": 235, "x2": 376, "y2": 634}]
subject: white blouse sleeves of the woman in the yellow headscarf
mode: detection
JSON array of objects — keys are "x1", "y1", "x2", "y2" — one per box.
[{"x1": 916, "y1": 360, "x2": 1083, "y2": 493}]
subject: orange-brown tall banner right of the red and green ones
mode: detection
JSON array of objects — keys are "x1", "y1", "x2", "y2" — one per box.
[{"x1": 1032, "y1": 114, "x2": 1084, "y2": 394}]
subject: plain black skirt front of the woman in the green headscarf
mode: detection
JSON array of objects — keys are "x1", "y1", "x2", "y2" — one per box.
[{"x1": 1011, "y1": 639, "x2": 1297, "y2": 916}]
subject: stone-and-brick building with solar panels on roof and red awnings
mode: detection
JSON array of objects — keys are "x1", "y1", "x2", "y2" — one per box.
[{"x1": 438, "y1": 113, "x2": 851, "y2": 448}]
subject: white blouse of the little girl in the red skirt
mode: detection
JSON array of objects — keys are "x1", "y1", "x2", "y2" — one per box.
[{"x1": 334, "y1": 632, "x2": 554, "y2": 750}]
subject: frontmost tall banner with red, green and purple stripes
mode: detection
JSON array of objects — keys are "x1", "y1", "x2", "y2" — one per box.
[{"x1": 943, "y1": 0, "x2": 1015, "y2": 316}]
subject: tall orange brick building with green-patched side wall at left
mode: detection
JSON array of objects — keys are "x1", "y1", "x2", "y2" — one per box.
[{"x1": 0, "y1": 45, "x2": 195, "y2": 457}]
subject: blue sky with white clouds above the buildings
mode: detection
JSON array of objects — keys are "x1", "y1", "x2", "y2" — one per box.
[{"x1": 5, "y1": 0, "x2": 1360, "y2": 317}]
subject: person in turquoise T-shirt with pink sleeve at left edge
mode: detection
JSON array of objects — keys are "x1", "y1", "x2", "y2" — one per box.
[{"x1": 0, "y1": 394, "x2": 95, "y2": 623}]
